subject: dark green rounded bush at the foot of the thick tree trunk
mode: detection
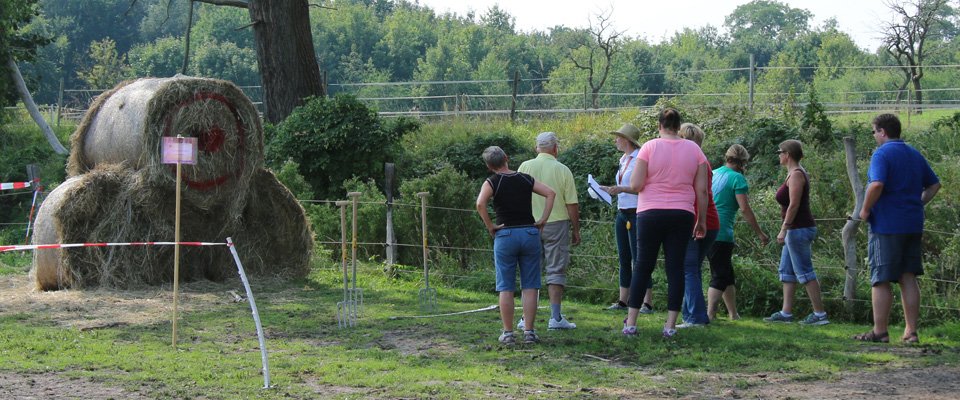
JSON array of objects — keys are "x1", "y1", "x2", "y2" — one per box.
[{"x1": 265, "y1": 94, "x2": 419, "y2": 199}]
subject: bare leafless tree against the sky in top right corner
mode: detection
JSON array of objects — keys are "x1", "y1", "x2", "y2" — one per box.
[{"x1": 883, "y1": 0, "x2": 953, "y2": 112}]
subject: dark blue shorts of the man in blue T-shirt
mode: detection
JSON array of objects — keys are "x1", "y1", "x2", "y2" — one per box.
[{"x1": 867, "y1": 232, "x2": 923, "y2": 286}]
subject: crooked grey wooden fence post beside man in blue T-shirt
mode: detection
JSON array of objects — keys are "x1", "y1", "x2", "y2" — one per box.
[{"x1": 841, "y1": 136, "x2": 864, "y2": 310}]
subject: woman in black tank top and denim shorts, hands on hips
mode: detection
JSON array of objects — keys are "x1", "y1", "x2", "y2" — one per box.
[{"x1": 477, "y1": 146, "x2": 556, "y2": 345}]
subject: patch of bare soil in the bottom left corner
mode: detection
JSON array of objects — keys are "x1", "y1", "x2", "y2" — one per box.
[{"x1": 0, "y1": 373, "x2": 149, "y2": 400}]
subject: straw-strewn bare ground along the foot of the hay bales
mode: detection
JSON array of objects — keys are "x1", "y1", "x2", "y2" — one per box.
[{"x1": 0, "y1": 275, "x2": 243, "y2": 330}]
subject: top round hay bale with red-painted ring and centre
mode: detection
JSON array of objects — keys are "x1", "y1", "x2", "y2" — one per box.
[{"x1": 67, "y1": 75, "x2": 263, "y2": 218}]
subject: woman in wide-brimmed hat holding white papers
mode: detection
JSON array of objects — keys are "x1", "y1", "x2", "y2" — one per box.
[{"x1": 600, "y1": 123, "x2": 653, "y2": 314}]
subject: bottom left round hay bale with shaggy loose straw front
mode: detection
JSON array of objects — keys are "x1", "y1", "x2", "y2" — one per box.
[{"x1": 34, "y1": 165, "x2": 248, "y2": 290}]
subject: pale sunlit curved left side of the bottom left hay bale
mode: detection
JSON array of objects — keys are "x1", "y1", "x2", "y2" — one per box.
[{"x1": 30, "y1": 177, "x2": 80, "y2": 290}]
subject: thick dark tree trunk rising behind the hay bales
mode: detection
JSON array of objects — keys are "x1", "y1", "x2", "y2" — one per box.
[{"x1": 249, "y1": 0, "x2": 324, "y2": 123}]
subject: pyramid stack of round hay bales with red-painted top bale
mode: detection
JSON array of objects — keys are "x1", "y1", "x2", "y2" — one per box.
[{"x1": 32, "y1": 76, "x2": 313, "y2": 290}]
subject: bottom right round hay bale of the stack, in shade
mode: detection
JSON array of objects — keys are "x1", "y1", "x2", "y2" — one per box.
[{"x1": 233, "y1": 169, "x2": 313, "y2": 278}]
